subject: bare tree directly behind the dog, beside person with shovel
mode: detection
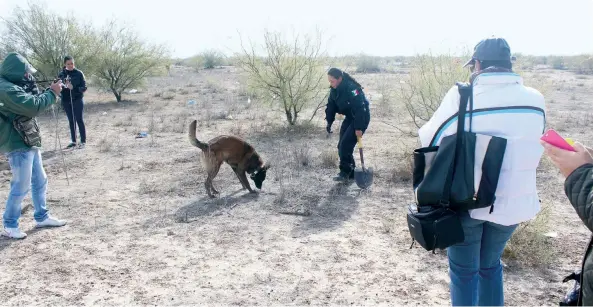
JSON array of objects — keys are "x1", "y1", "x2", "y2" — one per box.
[{"x1": 237, "y1": 31, "x2": 327, "y2": 125}]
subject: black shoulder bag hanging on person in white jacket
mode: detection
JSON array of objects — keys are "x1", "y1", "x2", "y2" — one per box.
[{"x1": 407, "y1": 83, "x2": 507, "y2": 252}]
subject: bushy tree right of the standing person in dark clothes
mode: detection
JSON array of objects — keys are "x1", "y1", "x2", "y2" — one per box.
[{"x1": 93, "y1": 22, "x2": 169, "y2": 102}]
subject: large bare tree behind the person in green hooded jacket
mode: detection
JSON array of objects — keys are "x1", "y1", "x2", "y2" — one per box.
[{"x1": 0, "y1": 3, "x2": 98, "y2": 78}]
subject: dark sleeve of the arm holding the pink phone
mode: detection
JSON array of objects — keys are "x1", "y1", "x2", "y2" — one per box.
[{"x1": 564, "y1": 164, "x2": 593, "y2": 232}]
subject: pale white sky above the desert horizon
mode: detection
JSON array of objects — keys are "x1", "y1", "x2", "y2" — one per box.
[{"x1": 0, "y1": 0, "x2": 593, "y2": 57}]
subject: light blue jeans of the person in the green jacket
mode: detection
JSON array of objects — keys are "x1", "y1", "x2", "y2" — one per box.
[{"x1": 4, "y1": 149, "x2": 48, "y2": 228}]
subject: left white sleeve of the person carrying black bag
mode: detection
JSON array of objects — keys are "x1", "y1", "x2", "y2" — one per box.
[{"x1": 418, "y1": 85, "x2": 461, "y2": 147}]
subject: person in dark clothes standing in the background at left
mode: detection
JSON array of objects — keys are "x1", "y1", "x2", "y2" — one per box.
[{"x1": 58, "y1": 56, "x2": 87, "y2": 148}]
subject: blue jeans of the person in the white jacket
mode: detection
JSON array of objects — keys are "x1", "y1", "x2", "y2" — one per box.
[{"x1": 447, "y1": 212, "x2": 517, "y2": 306}]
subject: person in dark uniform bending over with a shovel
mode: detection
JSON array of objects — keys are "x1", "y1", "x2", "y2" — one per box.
[{"x1": 325, "y1": 68, "x2": 371, "y2": 182}]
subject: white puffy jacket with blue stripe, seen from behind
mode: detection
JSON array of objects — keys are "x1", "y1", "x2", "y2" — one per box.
[{"x1": 419, "y1": 72, "x2": 546, "y2": 226}]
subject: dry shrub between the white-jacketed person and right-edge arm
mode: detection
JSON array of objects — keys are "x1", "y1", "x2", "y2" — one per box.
[{"x1": 503, "y1": 203, "x2": 554, "y2": 266}]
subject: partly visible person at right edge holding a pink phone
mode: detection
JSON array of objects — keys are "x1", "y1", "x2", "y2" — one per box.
[{"x1": 542, "y1": 141, "x2": 593, "y2": 306}]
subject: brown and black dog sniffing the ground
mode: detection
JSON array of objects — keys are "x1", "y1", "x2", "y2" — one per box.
[{"x1": 189, "y1": 120, "x2": 270, "y2": 197}]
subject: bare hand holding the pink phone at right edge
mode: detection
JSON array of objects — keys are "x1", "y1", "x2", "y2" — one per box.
[{"x1": 540, "y1": 141, "x2": 593, "y2": 177}]
